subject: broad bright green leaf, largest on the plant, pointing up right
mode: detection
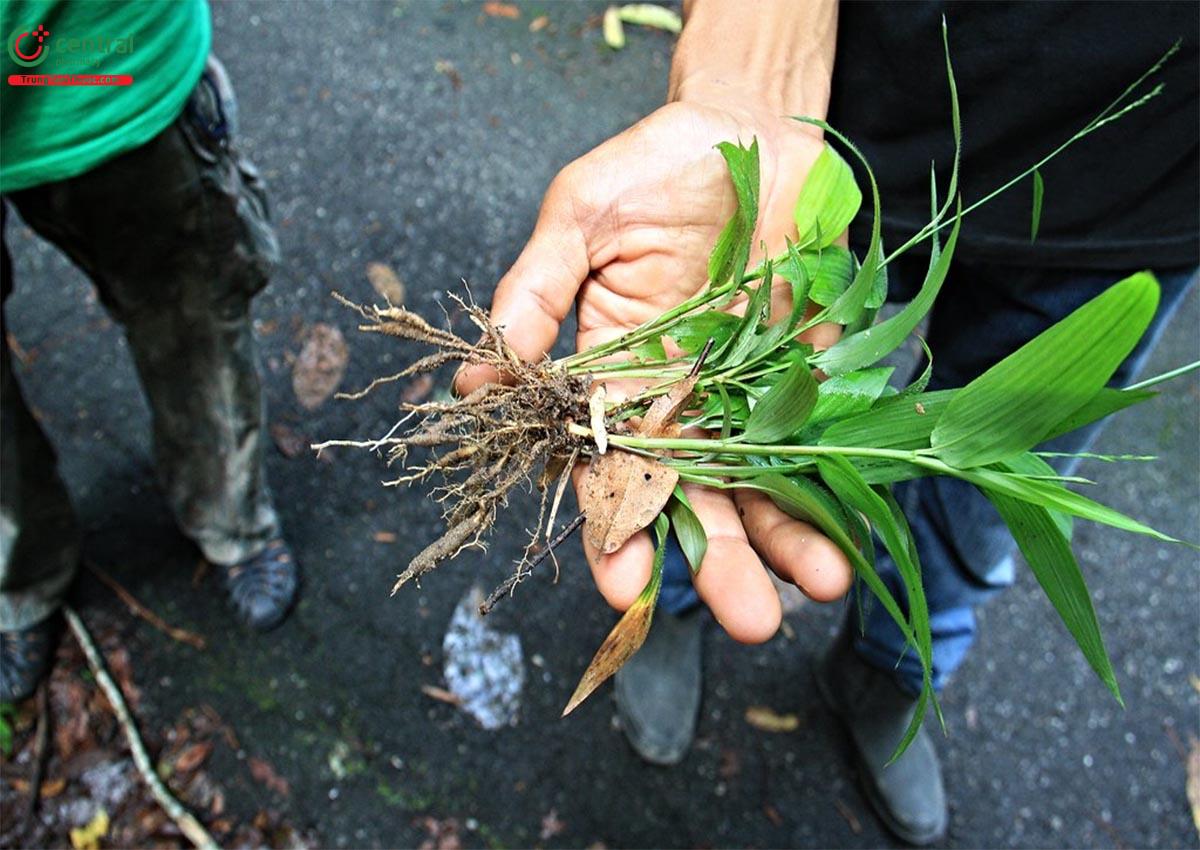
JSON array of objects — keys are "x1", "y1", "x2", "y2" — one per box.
[{"x1": 931, "y1": 271, "x2": 1158, "y2": 467}]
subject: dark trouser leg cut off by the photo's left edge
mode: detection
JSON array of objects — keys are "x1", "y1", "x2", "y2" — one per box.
[{"x1": 0, "y1": 206, "x2": 79, "y2": 631}]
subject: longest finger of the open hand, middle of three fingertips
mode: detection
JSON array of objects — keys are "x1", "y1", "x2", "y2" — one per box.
[{"x1": 684, "y1": 485, "x2": 782, "y2": 644}]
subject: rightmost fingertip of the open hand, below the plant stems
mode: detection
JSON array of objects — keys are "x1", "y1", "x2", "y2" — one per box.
[{"x1": 734, "y1": 490, "x2": 853, "y2": 601}]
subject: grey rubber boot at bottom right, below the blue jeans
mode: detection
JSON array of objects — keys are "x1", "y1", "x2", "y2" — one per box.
[{"x1": 816, "y1": 628, "x2": 949, "y2": 846}]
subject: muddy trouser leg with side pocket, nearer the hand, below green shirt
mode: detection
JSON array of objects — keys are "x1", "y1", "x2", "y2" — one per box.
[{"x1": 12, "y1": 56, "x2": 278, "y2": 564}]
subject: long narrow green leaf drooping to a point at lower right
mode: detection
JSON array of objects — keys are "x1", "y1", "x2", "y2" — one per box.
[{"x1": 984, "y1": 491, "x2": 1124, "y2": 706}]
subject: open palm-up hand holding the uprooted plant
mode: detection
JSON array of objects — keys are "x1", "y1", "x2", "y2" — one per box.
[{"x1": 458, "y1": 94, "x2": 851, "y2": 642}]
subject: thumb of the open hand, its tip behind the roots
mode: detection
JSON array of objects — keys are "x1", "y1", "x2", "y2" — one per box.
[{"x1": 455, "y1": 180, "x2": 590, "y2": 395}]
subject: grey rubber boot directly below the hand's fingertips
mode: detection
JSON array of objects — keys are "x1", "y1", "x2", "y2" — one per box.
[{"x1": 614, "y1": 609, "x2": 702, "y2": 765}]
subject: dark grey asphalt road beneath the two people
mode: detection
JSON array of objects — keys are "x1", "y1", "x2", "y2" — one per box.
[{"x1": 8, "y1": 2, "x2": 1200, "y2": 848}]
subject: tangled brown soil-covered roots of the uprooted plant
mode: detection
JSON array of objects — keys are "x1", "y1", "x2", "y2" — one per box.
[{"x1": 328, "y1": 297, "x2": 590, "y2": 593}]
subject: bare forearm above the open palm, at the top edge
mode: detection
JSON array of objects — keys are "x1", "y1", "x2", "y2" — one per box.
[{"x1": 667, "y1": 0, "x2": 838, "y2": 119}]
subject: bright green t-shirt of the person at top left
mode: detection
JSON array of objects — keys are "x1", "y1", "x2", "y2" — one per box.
[{"x1": 0, "y1": 0, "x2": 212, "y2": 192}]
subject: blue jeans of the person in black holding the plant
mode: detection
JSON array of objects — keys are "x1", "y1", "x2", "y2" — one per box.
[{"x1": 659, "y1": 257, "x2": 1196, "y2": 695}]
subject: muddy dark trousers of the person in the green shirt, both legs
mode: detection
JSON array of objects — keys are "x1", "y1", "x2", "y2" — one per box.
[{"x1": 0, "y1": 61, "x2": 278, "y2": 630}]
